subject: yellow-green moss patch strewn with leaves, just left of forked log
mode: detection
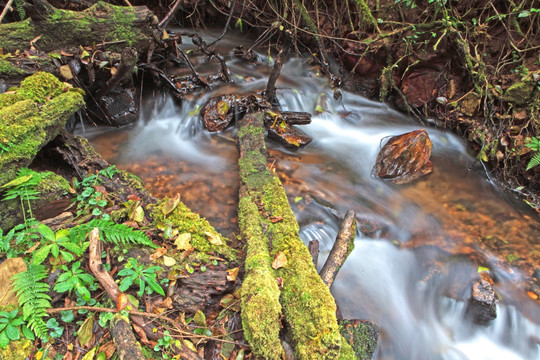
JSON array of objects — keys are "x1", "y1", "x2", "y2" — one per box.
[{"x1": 151, "y1": 198, "x2": 235, "y2": 260}]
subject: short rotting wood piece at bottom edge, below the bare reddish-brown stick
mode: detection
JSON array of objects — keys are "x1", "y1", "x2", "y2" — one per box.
[{"x1": 111, "y1": 314, "x2": 146, "y2": 360}]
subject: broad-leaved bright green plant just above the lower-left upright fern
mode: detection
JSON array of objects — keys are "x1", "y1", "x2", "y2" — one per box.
[{"x1": 33, "y1": 224, "x2": 83, "y2": 264}]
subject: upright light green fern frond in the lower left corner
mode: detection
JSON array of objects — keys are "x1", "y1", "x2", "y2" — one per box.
[{"x1": 13, "y1": 264, "x2": 51, "y2": 338}]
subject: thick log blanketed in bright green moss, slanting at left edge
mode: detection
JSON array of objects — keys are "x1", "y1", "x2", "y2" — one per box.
[{"x1": 0, "y1": 72, "x2": 84, "y2": 186}]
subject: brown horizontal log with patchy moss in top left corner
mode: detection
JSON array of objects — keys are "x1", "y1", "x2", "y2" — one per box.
[{"x1": 0, "y1": 0, "x2": 157, "y2": 52}]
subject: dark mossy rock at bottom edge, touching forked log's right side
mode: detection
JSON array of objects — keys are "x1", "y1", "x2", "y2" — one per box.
[{"x1": 339, "y1": 320, "x2": 379, "y2": 360}]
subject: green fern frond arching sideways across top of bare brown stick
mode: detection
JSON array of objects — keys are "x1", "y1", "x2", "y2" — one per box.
[{"x1": 72, "y1": 219, "x2": 156, "y2": 248}]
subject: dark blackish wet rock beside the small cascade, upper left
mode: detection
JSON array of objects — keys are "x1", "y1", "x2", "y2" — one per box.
[{"x1": 101, "y1": 87, "x2": 139, "y2": 127}]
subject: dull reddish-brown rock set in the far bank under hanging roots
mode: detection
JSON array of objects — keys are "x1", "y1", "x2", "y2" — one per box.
[{"x1": 401, "y1": 68, "x2": 441, "y2": 107}]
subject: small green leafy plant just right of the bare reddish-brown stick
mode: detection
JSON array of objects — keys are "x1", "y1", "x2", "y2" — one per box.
[{"x1": 118, "y1": 258, "x2": 165, "y2": 297}]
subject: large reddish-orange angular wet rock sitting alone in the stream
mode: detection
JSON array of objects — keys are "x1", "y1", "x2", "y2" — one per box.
[{"x1": 373, "y1": 129, "x2": 433, "y2": 184}]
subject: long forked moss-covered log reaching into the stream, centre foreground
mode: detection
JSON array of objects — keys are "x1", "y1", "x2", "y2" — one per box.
[{"x1": 237, "y1": 113, "x2": 354, "y2": 359}]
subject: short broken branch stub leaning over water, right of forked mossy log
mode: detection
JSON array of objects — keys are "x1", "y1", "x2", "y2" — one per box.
[{"x1": 319, "y1": 210, "x2": 356, "y2": 288}]
